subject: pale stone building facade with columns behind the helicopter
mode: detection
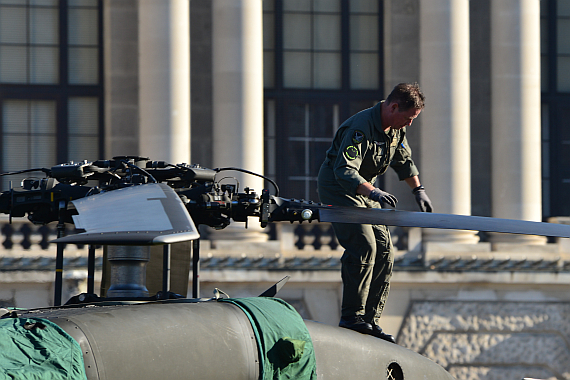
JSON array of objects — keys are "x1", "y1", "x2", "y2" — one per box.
[{"x1": 0, "y1": 0, "x2": 570, "y2": 379}]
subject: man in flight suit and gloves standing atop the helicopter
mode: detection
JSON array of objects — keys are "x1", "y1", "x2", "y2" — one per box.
[{"x1": 318, "y1": 83, "x2": 432, "y2": 343}]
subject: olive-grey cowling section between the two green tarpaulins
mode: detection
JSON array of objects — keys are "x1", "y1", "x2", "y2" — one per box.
[{"x1": 36, "y1": 302, "x2": 259, "y2": 380}]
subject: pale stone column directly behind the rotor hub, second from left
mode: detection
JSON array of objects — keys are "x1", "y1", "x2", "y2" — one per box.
[{"x1": 211, "y1": 0, "x2": 266, "y2": 240}]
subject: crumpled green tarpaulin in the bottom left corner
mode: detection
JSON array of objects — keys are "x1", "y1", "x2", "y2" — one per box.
[{"x1": 0, "y1": 318, "x2": 87, "y2": 380}]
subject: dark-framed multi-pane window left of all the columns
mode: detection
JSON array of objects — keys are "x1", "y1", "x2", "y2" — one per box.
[{"x1": 0, "y1": 0, "x2": 103, "y2": 190}]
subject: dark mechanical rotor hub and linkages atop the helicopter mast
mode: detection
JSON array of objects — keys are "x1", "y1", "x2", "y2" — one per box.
[{"x1": 0, "y1": 156, "x2": 318, "y2": 229}]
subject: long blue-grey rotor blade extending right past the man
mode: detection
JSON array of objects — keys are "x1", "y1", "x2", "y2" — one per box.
[{"x1": 319, "y1": 206, "x2": 570, "y2": 238}]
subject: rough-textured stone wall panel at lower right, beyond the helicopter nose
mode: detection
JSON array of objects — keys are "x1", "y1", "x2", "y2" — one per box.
[{"x1": 398, "y1": 301, "x2": 570, "y2": 380}]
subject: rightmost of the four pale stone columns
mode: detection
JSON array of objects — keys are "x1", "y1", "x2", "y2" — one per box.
[{"x1": 491, "y1": 0, "x2": 545, "y2": 244}]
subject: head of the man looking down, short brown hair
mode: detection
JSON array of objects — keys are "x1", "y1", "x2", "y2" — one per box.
[{"x1": 382, "y1": 83, "x2": 425, "y2": 130}]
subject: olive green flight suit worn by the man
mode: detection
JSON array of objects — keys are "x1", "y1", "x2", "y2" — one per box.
[{"x1": 318, "y1": 103, "x2": 419, "y2": 324}]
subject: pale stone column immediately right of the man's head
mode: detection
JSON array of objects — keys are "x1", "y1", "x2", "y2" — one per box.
[{"x1": 411, "y1": 0, "x2": 478, "y2": 243}]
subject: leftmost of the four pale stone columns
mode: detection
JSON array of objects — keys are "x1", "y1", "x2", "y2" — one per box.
[{"x1": 138, "y1": 0, "x2": 190, "y2": 164}]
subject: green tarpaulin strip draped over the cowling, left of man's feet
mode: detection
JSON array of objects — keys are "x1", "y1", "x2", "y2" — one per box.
[{"x1": 220, "y1": 297, "x2": 317, "y2": 380}]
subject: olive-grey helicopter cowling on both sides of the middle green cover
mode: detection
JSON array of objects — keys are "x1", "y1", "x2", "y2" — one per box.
[{"x1": 18, "y1": 299, "x2": 453, "y2": 380}]
